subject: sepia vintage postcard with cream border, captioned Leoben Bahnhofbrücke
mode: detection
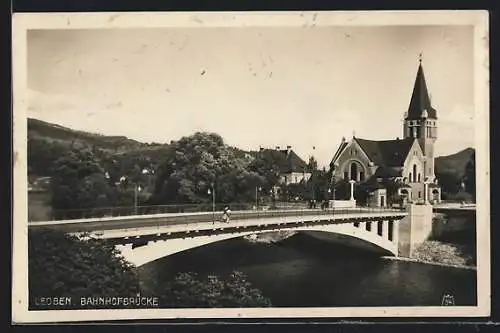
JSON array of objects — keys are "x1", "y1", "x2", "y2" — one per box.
[{"x1": 12, "y1": 11, "x2": 490, "y2": 323}]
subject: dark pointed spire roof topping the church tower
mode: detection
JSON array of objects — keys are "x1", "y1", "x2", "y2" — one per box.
[{"x1": 406, "y1": 62, "x2": 437, "y2": 120}]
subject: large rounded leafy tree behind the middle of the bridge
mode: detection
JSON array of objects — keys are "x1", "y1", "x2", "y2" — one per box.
[{"x1": 154, "y1": 132, "x2": 264, "y2": 203}]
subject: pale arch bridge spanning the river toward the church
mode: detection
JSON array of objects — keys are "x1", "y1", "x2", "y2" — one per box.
[{"x1": 29, "y1": 207, "x2": 432, "y2": 266}]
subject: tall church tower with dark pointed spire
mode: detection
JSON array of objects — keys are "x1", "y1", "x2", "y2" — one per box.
[{"x1": 403, "y1": 55, "x2": 437, "y2": 181}]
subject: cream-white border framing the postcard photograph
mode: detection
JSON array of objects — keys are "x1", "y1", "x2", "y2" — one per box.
[{"x1": 12, "y1": 11, "x2": 491, "y2": 323}]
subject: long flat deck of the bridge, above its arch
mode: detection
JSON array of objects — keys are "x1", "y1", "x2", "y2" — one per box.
[{"x1": 29, "y1": 208, "x2": 407, "y2": 238}]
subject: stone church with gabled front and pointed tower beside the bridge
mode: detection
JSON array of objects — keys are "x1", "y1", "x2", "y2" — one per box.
[{"x1": 330, "y1": 59, "x2": 441, "y2": 207}]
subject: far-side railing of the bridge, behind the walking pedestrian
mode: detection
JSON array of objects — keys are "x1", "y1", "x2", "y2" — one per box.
[{"x1": 42, "y1": 202, "x2": 307, "y2": 222}]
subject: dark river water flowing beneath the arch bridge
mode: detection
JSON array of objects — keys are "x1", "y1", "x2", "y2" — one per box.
[{"x1": 140, "y1": 228, "x2": 477, "y2": 307}]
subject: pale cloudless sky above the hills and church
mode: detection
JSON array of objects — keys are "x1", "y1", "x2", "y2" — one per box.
[{"x1": 28, "y1": 26, "x2": 474, "y2": 166}]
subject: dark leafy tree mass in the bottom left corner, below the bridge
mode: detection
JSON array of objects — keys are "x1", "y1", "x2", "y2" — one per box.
[{"x1": 28, "y1": 230, "x2": 139, "y2": 309}]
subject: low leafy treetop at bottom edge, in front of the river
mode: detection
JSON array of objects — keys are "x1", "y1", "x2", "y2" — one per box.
[{"x1": 161, "y1": 271, "x2": 271, "y2": 308}]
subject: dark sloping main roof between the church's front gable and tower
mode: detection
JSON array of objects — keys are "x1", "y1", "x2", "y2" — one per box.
[{"x1": 354, "y1": 138, "x2": 415, "y2": 167}]
